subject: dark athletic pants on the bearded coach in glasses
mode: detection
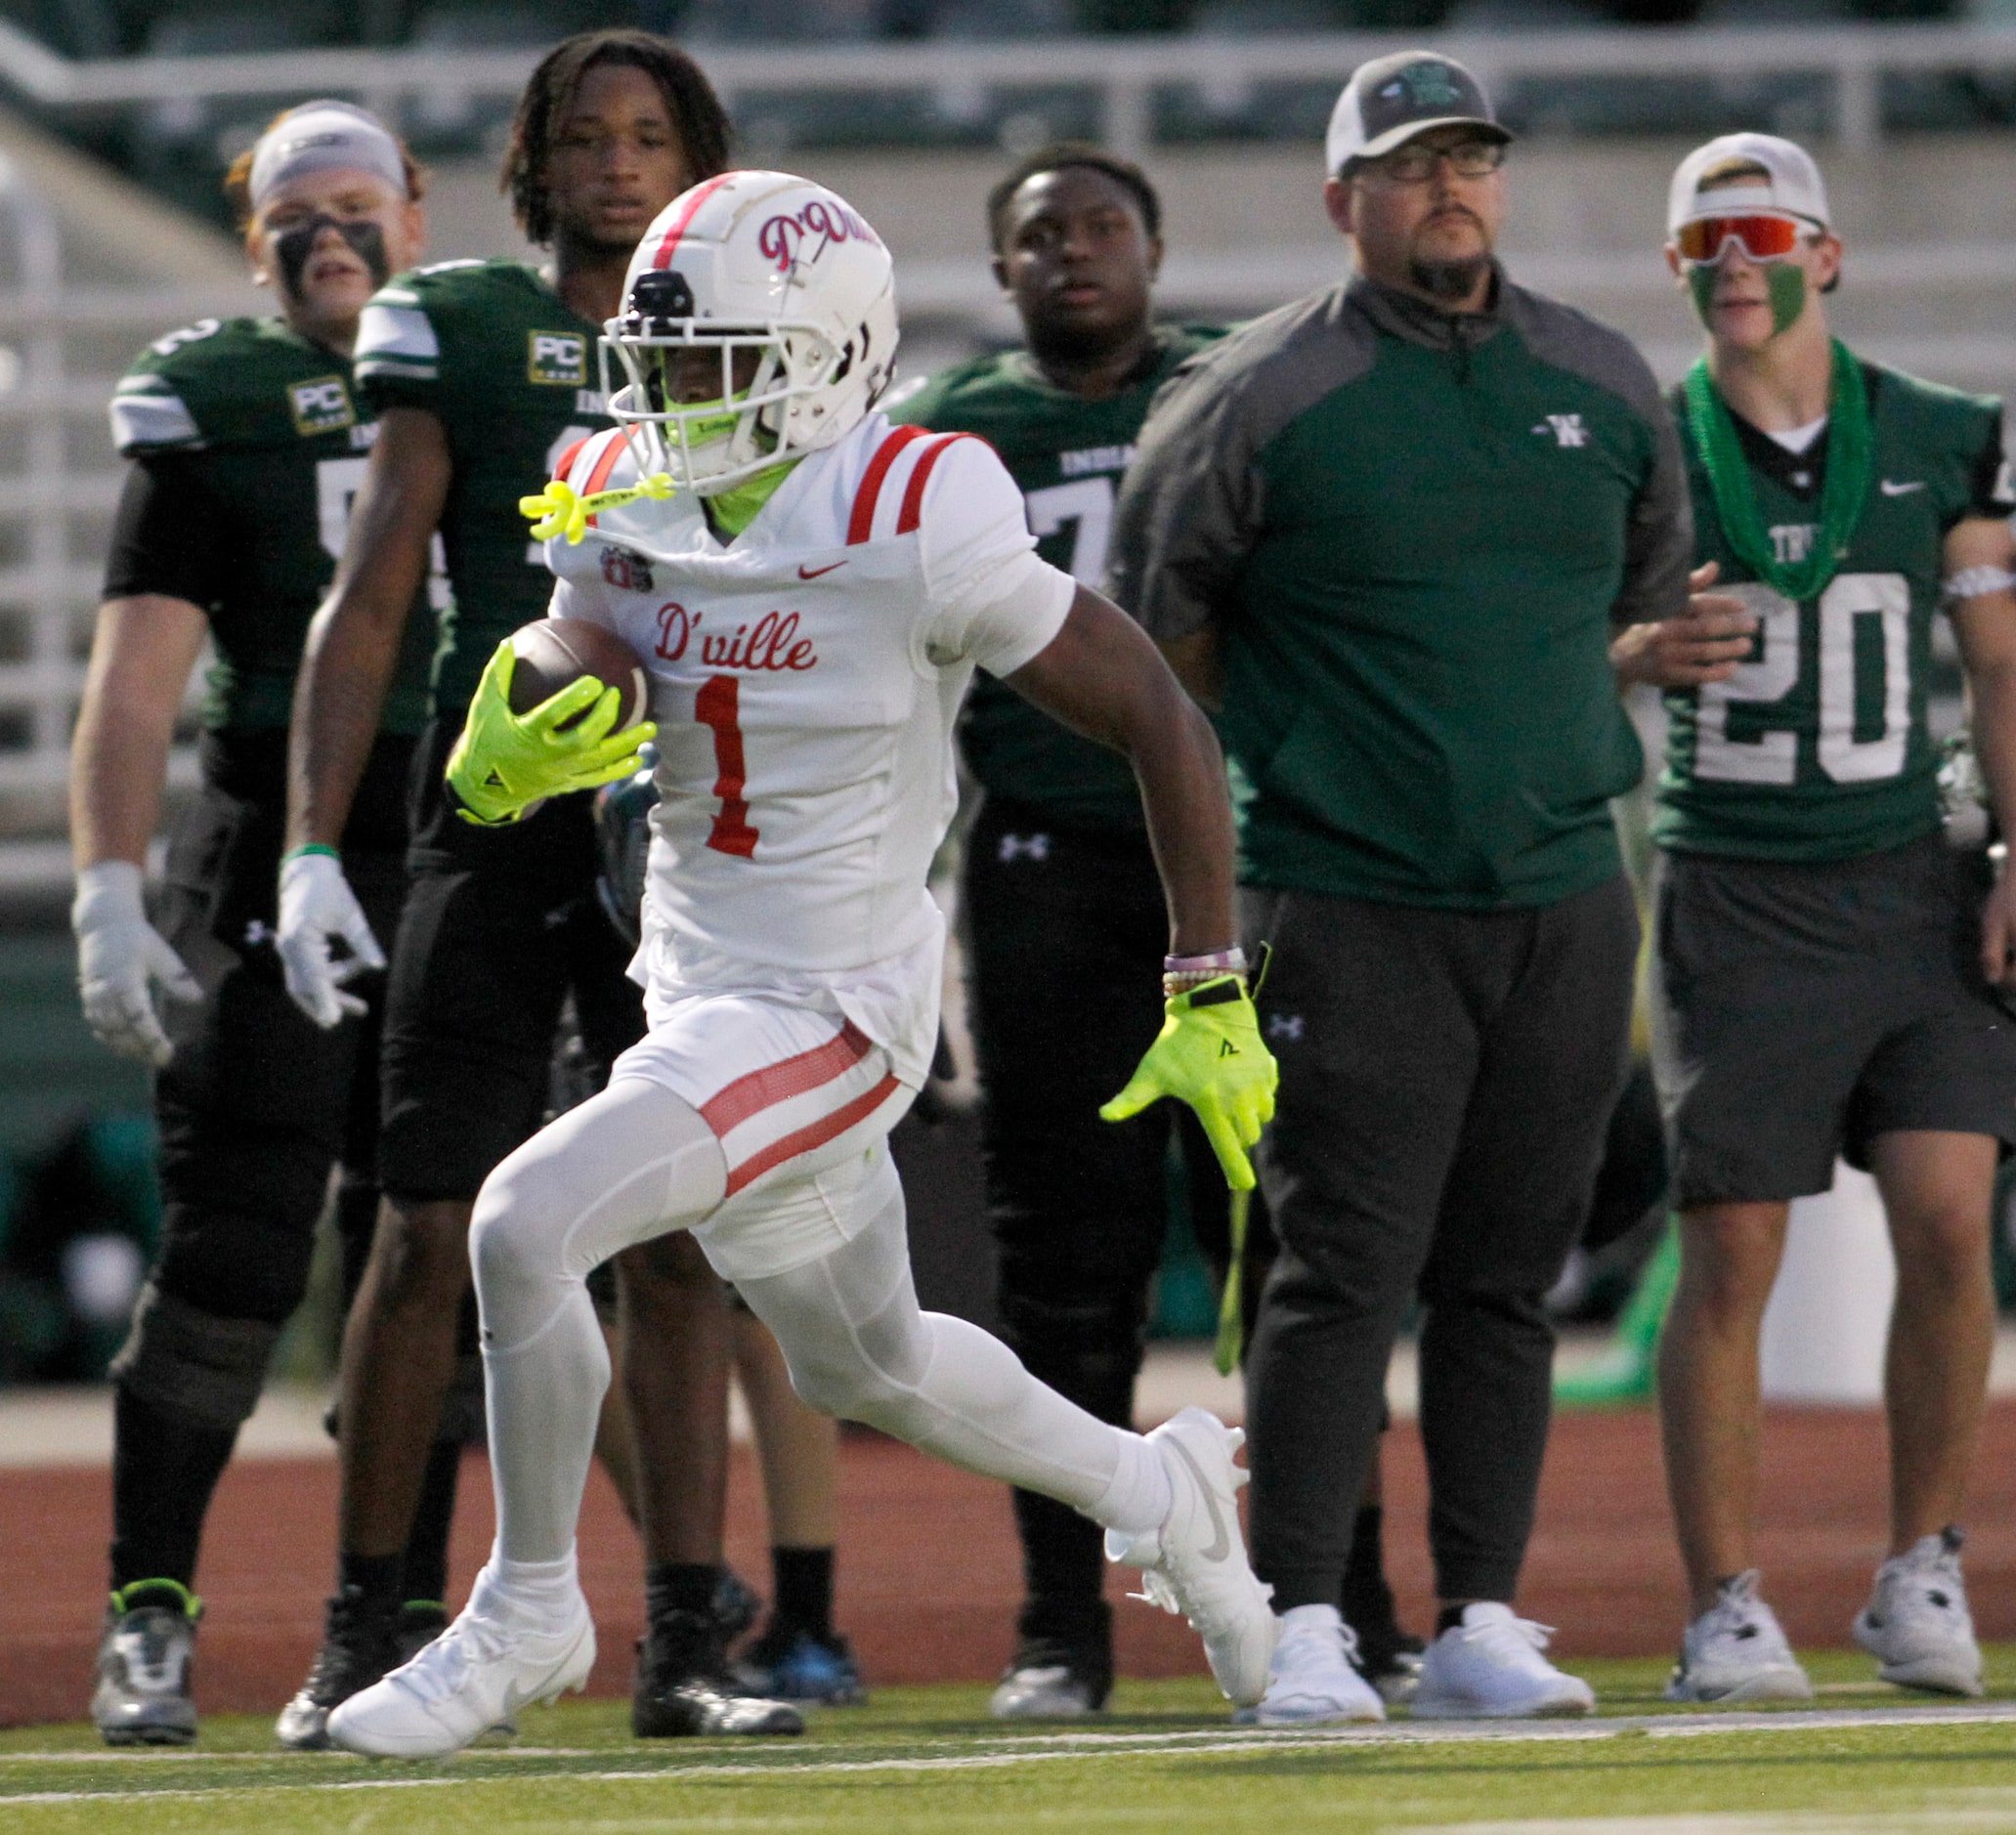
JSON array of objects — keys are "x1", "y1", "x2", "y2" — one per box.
[{"x1": 1242, "y1": 877, "x2": 1639, "y2": 1611}]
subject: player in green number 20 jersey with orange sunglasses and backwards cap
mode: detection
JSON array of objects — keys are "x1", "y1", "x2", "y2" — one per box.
[{"x1": 1653, "y1": 133, "x2": 2016, "y2": 1700}]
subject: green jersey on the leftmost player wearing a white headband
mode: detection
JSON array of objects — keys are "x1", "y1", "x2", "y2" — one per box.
[{"x1": 107, "y1": 319, "x2": 431, "y2": 734}]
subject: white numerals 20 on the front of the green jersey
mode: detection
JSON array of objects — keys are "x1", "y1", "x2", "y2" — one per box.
[{"x1": 1694, "y1": 573, "x2": 1911, "y2": 785}]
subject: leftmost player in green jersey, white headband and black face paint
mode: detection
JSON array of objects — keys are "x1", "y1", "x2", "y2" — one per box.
[{"x1": 70, "y1": 103, "x2": 429, "y2": 1744}]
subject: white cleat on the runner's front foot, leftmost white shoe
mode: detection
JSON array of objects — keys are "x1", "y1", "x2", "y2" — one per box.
[{"x1": 328, "y1": 1579, "x2": 595, "y2": 1759}]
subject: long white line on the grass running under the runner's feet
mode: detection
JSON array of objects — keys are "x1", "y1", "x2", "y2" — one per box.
[{"x1": 12, "y1": 1702, "x2": 2016, "y2": 1827}]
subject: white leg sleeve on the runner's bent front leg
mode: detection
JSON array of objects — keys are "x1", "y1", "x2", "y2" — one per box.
[{"x1": 470, "y1": 1079, "x2": 728, "y2": 1562}]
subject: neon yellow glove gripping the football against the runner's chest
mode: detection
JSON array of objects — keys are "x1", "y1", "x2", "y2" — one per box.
[{"x1": 448, "y1": 637, "x2": 658, "y2": 827}]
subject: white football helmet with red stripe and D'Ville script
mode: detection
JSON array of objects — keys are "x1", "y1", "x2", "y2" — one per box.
[{"x1": 601, "y1": 171, "x2": 897, "y2": 496}]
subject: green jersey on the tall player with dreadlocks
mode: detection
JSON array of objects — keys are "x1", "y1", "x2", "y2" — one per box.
[{"x1": 357, "y1": 260, "x2": 611, "y2": 716}]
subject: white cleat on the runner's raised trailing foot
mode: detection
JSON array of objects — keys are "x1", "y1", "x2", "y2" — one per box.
[{"x1": 1107, "y1": 1407, "x2": 1280, "y2": 1708}]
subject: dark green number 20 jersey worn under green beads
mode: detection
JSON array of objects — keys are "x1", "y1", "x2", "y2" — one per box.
[{"x1": 1653, "y1": 363, "x2": 2012, "y2": 861}]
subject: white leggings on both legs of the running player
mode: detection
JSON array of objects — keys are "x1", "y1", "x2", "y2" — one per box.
[{"x1": 470, "y1": 1077, "x2": 1170, "y2": 1564}]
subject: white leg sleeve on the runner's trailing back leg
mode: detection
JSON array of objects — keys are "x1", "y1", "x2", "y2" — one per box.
[{"x1": 736, "y1": 1145, "x2": 1170, "y2": 1528}]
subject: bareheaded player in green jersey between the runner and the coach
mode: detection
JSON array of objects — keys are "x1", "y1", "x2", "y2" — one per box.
[{"x1": 889, "y1": 146, "x2": 1419, "y2": 1720}]
